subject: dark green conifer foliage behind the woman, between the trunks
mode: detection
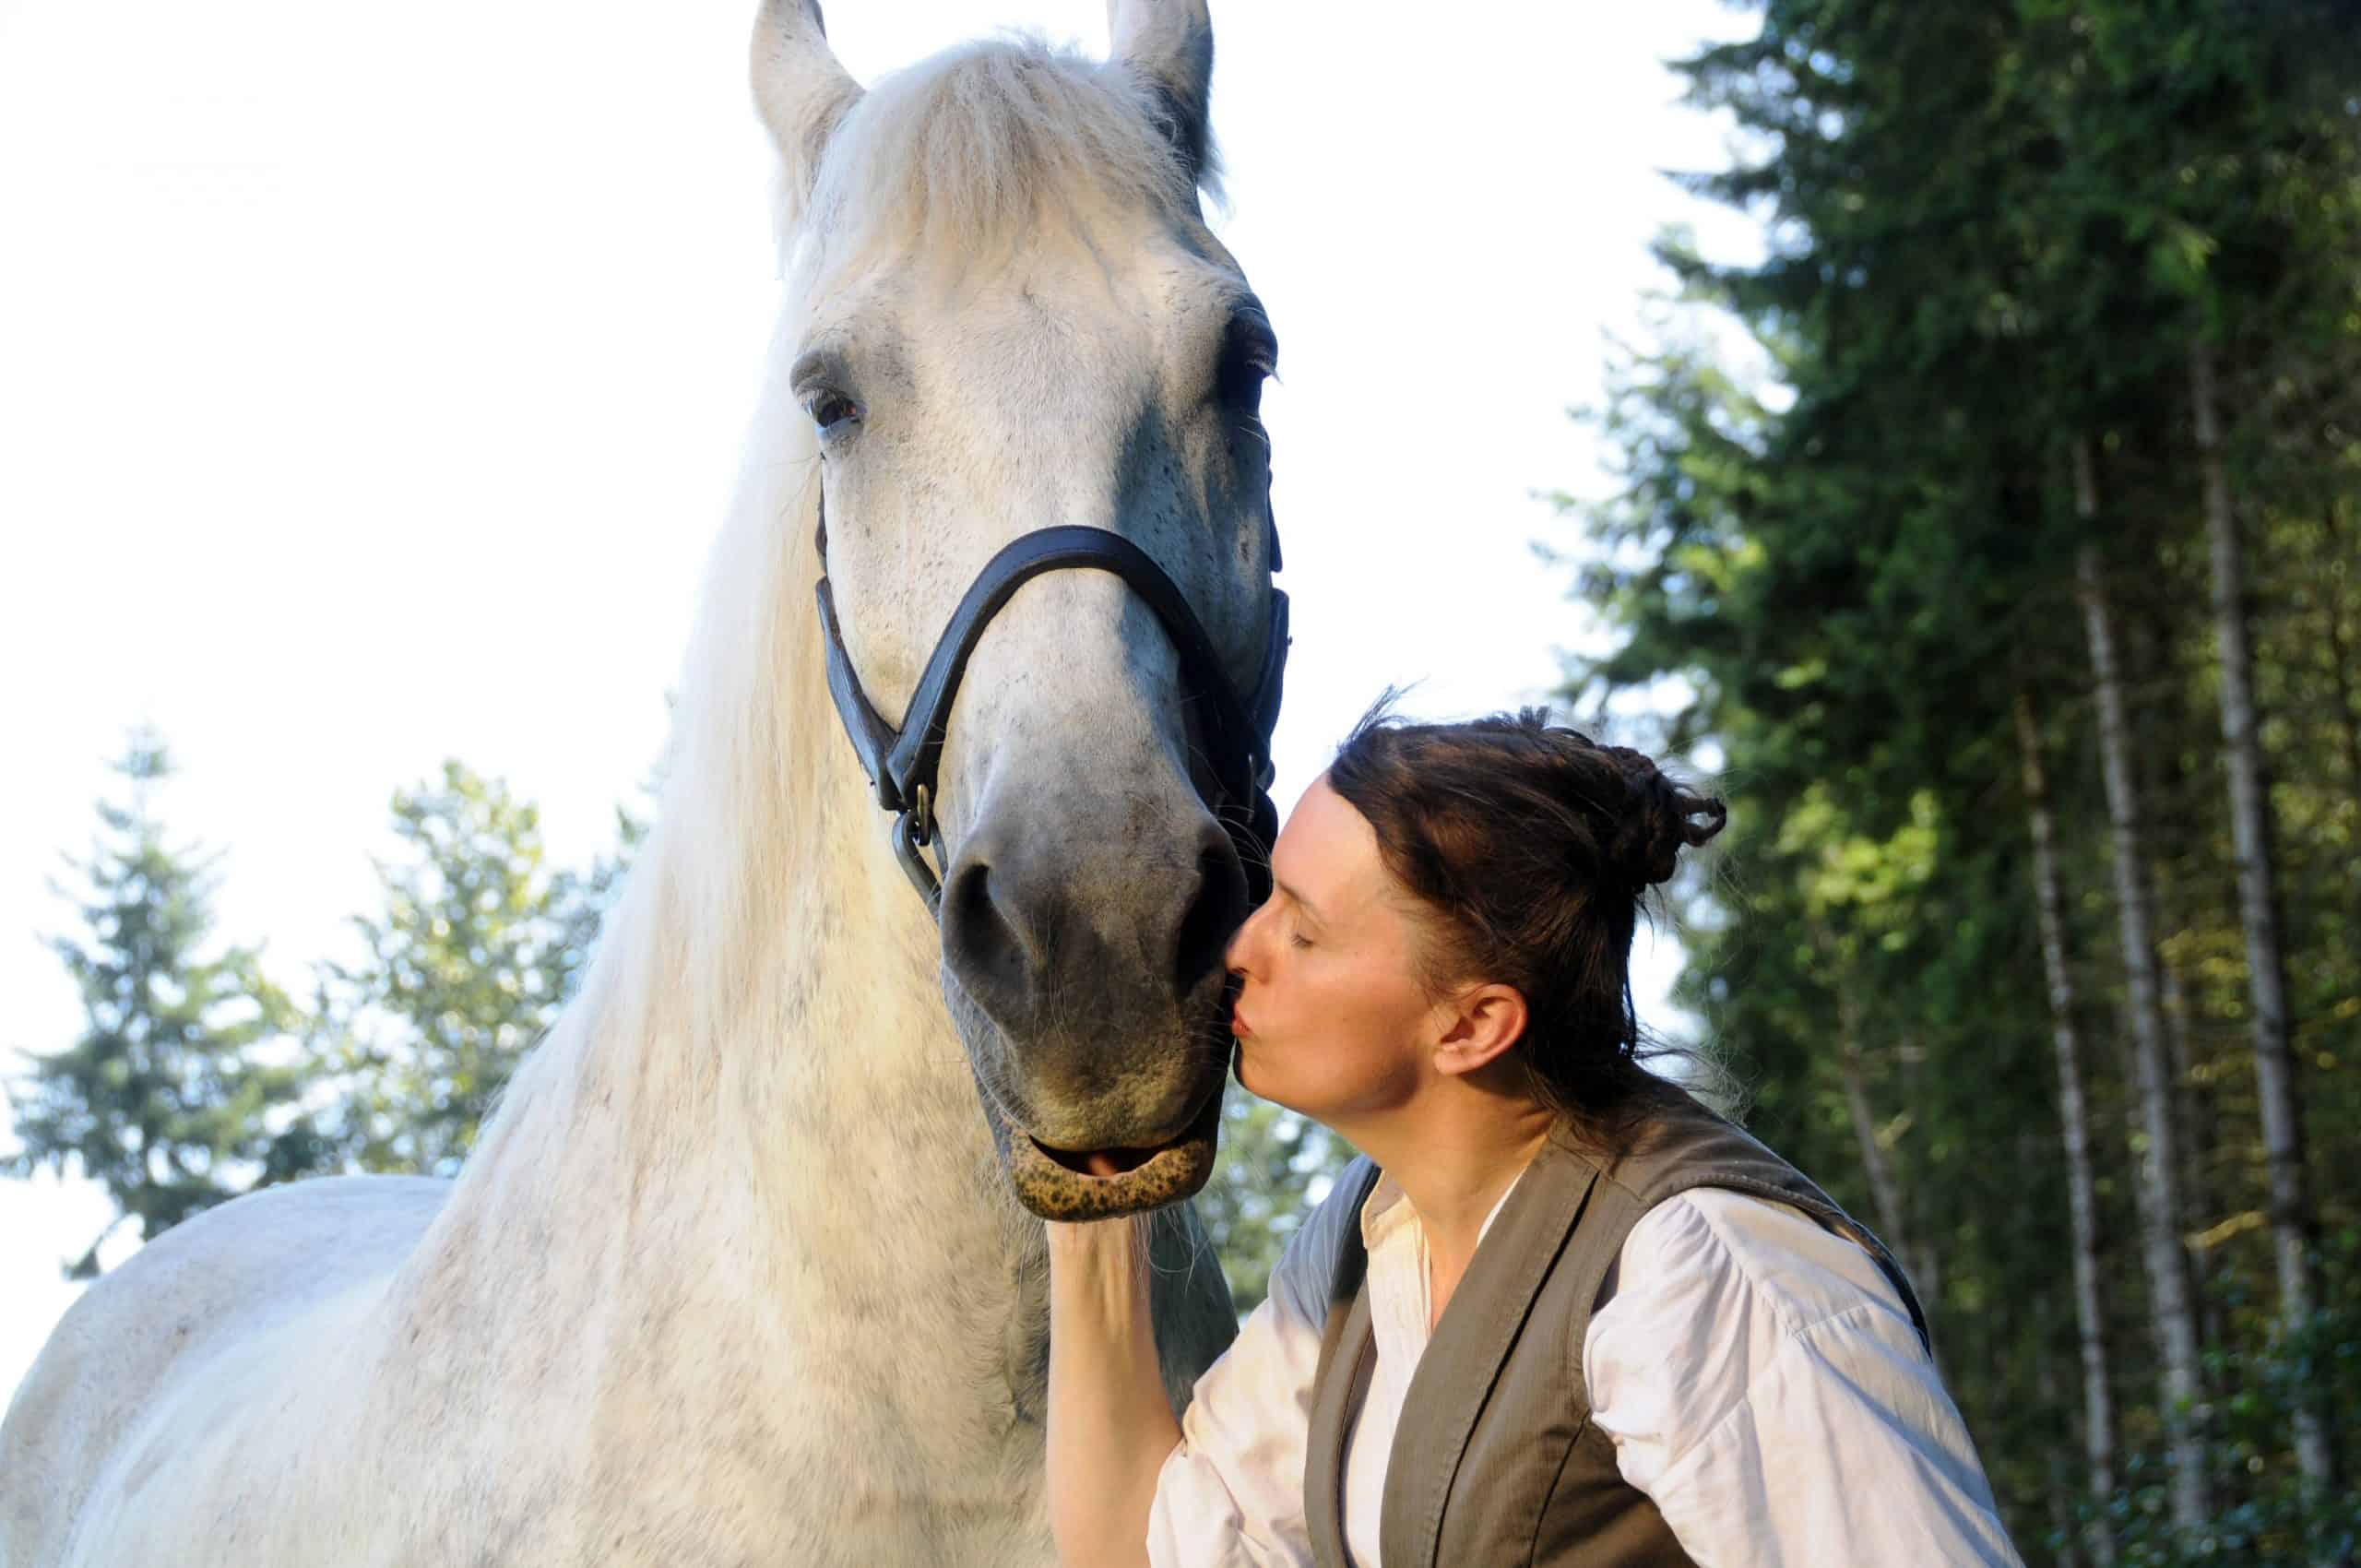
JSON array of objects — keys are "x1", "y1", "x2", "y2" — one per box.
[{"x1": 1563, "y1": 0, "x2": 2361, "y2": 1563}]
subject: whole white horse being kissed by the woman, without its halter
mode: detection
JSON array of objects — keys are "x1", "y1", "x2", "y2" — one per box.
[{"x1": 0, "y1": 0, "x2": 1275, "y2": 1568}]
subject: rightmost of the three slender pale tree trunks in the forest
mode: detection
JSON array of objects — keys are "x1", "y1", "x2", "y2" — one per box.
[{"x1": 2189, "y1": 340, "x2": 2335, "y2": 1492}]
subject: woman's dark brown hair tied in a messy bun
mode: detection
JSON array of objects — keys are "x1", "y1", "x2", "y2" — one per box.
[{"x1": 1327, "y1": 692, "x2": 1728, "y2": 1150}]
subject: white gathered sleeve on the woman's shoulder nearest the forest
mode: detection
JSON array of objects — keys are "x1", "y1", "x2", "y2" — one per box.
[{"x1": 1582, "y1": 1188, "x2": 2021, "y2": 1568}]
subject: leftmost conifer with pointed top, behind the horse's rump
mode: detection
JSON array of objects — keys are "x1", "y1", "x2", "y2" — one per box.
[{"x1": 0, "y1": 732, "x2": 314, "y2": 1277}]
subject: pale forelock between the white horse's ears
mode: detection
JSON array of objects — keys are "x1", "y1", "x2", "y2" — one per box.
[{"x1": 781, "y1": 35, "x2": 1221, "y2": 267}]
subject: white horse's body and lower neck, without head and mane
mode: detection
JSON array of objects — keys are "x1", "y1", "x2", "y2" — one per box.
[{"x1": 14, "y1": 585, "x2": 1230, "y2": 1568}]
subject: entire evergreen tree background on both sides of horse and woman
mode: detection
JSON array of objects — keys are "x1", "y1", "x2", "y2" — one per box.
[{"x1": 14, "y1": 0, "x2": 2361, "y2": 1565}]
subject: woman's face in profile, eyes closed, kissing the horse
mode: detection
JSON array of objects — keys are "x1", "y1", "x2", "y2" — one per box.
[{"x1": 1230, "y1": 775, "x2": 1441, "y2": 1129}]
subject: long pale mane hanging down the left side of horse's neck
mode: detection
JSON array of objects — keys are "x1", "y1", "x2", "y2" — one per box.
[{"x1": 463, "y1": 318, "x2": 836, "y2": 1181}]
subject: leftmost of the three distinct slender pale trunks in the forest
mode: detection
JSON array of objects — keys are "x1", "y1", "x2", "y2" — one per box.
[{"x1": 2016, "y1": 687, "x2": 2116, "y2": 1568}]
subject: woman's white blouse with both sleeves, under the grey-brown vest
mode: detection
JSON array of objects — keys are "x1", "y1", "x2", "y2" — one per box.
[{"x1": 1147, "y1": 1176, "x2": 2021, "y2": 1568}]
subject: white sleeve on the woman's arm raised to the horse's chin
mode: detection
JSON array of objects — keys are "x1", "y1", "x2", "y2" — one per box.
[{"x1": 1147, "y1": 1162, "x2": 1365, "y2": 1568}]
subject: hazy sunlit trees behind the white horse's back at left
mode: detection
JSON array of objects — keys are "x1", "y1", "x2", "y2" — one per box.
[{"x1": 14, "y1": 734, "x2": 647, "y2": 1237}]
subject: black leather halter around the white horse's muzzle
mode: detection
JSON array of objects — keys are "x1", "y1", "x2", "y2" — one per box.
[{"x1": 814, "y1": 491, "x2": 1287, "y2": 909}]
